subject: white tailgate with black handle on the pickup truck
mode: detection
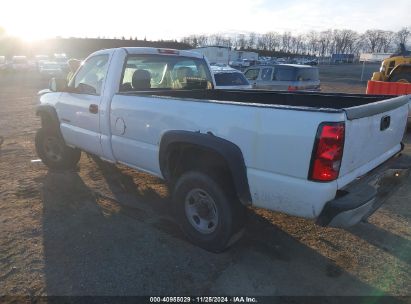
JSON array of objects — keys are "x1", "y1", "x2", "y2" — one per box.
[{"x1": 338, "y1": 96, "x2": 408, "y2": 188}]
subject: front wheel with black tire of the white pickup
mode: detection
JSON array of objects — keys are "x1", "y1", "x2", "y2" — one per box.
[{"x1": 35, "y1": 128, "x2": 81, "y2": 170}]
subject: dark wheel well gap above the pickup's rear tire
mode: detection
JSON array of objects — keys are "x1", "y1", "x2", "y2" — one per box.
[{"x1": 166, "y1": 143, "x2": 234, "y2": 189}]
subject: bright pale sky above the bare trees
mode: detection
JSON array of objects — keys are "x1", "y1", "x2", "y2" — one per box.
[{"x1": 0, "y1": 0, "x2": 411, "y2": 41}]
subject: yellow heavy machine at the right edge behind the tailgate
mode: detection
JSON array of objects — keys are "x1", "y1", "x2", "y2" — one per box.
[{"x1": 371, "y1": 44, "x2": 411, "y2": 83}]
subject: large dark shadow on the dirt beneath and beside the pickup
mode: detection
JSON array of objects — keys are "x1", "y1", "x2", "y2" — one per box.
[{"x1": 42, "y1": 164, "x2": 395, "y2": 296}]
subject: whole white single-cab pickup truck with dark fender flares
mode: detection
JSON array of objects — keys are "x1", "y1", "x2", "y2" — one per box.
[{"x1": 36, "y1": 48, "x2": 410, "y2": 252}]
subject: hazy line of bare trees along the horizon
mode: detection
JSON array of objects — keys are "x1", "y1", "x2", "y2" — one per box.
[{"x1": 0, "y1": 27, "x2": 411, "y2": 57}]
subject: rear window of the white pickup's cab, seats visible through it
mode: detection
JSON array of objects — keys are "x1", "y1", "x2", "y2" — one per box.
[{"x1": 120, "y1": 55, "x2": 212, "y2": 92}]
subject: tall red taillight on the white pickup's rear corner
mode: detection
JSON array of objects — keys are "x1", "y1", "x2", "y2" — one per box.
[{"x1": 308, "y1": 122, "x2": 345, "y2": 182}]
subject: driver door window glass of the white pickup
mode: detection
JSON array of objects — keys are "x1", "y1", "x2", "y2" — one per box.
[{"x1": 69, "y1": 55, "x2": 109, "y2": 95}]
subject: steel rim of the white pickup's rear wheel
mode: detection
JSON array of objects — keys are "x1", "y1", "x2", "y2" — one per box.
[{"x1": 185, "y1": 189, "x2": 218, "y2": 234}]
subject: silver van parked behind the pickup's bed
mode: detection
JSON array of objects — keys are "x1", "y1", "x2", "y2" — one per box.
[{"x1": 244, "y1": 64, "x2": 320, "y2": 91}]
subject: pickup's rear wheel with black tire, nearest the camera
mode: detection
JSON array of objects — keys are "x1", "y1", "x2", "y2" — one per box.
[{"x1": 173, "y1": 171, "x2": 246, "y2": 252}]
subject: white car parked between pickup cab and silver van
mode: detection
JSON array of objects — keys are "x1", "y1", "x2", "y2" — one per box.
[{"x1": 211, "y1": 66, "x2": 252, "y2": 90}]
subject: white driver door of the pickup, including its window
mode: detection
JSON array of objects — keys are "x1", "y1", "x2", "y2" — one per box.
[{"x1": 56, "y1": 54, "x2": 109, "y2": 155}]
